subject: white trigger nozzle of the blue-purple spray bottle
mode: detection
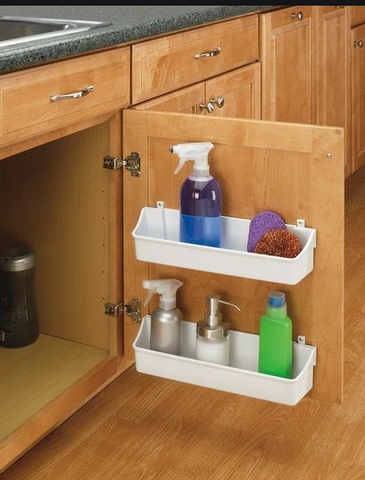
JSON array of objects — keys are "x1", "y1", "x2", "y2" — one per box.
[{"x1": 170, "y1": 142, "x2": 214, "y2": 176}]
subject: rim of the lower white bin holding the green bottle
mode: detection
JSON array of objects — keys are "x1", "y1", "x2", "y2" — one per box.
[{"x1": 133, "y1": 315, "x2": 315, "y2": 384}]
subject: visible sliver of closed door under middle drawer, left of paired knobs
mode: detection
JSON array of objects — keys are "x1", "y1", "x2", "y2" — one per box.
[{"x1": 135, "y1": 83, "x2": 205, "y2": 114}]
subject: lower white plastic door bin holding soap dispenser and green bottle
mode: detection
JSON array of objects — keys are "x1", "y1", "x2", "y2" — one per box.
[{"x1": 133, "y1": 315, "x2": 316, "y2": 405}]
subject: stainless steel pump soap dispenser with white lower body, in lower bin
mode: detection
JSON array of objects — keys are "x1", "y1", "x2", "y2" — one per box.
[{"x1": 196, "y1": 295, "x2": 241, "y2": 365}]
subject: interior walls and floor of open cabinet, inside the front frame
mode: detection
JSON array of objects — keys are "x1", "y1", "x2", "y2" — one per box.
[{"x1": 0, "y1": 122, "x2": 112, "y2": 438}]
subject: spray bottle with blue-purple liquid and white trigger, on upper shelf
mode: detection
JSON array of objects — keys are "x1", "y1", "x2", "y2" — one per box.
[{"x1": 170, "y1": 142, "x2": 222, "y2": 247}]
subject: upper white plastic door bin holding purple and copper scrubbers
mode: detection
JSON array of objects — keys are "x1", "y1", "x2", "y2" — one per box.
[{"x1": 132, "y1": 207, "x2": 316, "y2": 285}]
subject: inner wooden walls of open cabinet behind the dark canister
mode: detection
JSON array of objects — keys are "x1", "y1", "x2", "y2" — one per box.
[{"x1": 0, "y1": 123, "x2": 111, "y2": 350}]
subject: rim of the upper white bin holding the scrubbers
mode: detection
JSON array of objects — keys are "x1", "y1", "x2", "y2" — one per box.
[{"x1": 132, "y1": 207, "x2": 316, "y2": 264}]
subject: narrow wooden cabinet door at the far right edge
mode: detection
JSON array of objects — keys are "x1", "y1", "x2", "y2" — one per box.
[{"x1": 352, "y1": 25, "x2": 365, "y2": 171}]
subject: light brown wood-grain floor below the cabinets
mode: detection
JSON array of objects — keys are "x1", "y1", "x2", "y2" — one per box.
[{"x1": 1, "y1": 170, "x2": 365, "y2": 480}]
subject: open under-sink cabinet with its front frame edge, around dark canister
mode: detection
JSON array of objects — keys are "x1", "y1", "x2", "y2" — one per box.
[{"x1": 0, "y1": 113, "x2": 132, "y2": 469}]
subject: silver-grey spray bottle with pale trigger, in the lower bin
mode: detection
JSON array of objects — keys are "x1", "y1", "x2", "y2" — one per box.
[{"x1": 142, "y1": 279, "x2": 183, "y2": 355}]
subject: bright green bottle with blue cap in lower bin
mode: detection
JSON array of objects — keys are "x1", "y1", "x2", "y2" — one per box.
[{"x1": 259, "y1": 292, "x2": 293, "y2": 378}]
